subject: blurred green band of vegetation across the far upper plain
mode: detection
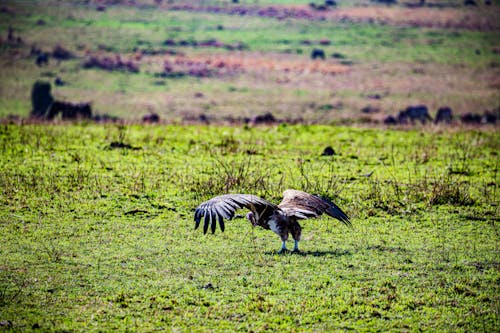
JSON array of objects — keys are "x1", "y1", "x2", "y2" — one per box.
[{"x1": 0, "y1": 2, "x2": 498, "y2": 63}]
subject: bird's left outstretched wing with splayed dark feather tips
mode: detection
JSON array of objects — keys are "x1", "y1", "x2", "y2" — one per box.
[{"x1": 194, "y1": 194, "x2": 277, "y2": 233}]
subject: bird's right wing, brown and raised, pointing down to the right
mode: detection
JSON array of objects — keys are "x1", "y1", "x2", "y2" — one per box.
[{"x1": 278, "y1": 190, "x2": 352, "y2": 227}]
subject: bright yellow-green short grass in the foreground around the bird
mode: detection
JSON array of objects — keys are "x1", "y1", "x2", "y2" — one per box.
[{"x1": 0, "y1": 124, "x2": 500, "y2": 332}]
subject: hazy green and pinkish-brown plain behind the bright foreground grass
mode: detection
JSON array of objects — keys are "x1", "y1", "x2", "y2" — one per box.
[{"x1": 0, "y1": 1, "x2": 500, "y2": 124}]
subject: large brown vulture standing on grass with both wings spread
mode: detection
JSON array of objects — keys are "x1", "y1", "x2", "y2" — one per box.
[{"x1": 194, "y1": 189, "x2": 352, "y2": 253}]
